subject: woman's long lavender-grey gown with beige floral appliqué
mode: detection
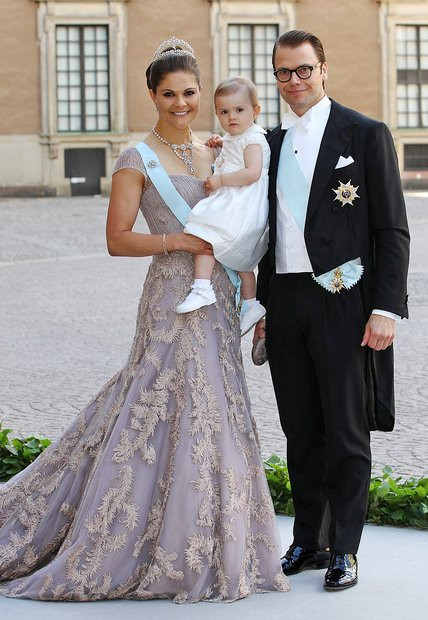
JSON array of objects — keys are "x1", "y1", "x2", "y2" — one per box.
[{"x1": 0, "y1": 148, "x2": 289, "y2": 602}]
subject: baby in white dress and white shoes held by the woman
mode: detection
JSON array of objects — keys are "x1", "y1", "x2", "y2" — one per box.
[{"x1": 177, "y1": 77, "x2": 270, "y2": 335}]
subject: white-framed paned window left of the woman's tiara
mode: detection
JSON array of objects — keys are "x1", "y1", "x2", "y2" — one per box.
[{"x1": 56, "y1": 25, "x2": 110, "y2": 132}]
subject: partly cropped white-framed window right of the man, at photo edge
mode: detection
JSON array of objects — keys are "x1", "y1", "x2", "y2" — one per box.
[{"x1": 395, "y1": 25, "x2": 428, "y2": 128}]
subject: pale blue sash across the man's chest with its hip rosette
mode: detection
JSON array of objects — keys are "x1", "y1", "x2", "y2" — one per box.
[{"x1": 277, "y1": 127, "x2": 364, "y2": 293}]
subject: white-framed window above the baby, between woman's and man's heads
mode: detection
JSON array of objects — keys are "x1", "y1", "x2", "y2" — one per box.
[{"x1": 227, "y1": 24, "x2": 280, "y2": 128}]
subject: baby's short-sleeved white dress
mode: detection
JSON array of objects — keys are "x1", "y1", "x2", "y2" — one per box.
[{"x1": 184, "y1": 124, "x2": 270, "y2": 271}]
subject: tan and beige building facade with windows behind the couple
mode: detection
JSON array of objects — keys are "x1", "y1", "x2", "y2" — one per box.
[{"x1": 0, "y1": 0, "x2": 428, "y2": 195}]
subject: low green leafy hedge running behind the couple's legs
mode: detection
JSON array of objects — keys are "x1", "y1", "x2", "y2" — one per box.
[{"x1": 0, "y1": 422, "x2": 428, "y2": 529}]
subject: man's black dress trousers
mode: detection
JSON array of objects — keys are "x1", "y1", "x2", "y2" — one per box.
[{"x1": 266, "y1": 273, "x2": 371, "y2": 553}]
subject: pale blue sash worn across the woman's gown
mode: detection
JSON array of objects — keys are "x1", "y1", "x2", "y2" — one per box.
[{"x1": 135, "y1": 142, "x2": 241, "y2": 307}]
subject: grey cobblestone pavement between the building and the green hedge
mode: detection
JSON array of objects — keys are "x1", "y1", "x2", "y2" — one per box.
[{"x1": 0, "y1": 193, "x2": 428, "y2": 476}]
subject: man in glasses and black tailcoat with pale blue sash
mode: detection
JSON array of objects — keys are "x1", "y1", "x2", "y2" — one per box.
[{"x1": 255, "y1": 30, "x2": 409, "y2": 590}]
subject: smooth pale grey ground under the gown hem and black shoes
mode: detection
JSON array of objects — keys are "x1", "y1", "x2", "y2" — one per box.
[{"x1": 0, "y1": 517, "x2": 428, "y2": 620}]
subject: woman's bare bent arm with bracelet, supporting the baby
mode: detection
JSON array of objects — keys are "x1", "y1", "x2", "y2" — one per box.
[{"x1": 106, "y1": 168, "x2": 212, "y2": 256}]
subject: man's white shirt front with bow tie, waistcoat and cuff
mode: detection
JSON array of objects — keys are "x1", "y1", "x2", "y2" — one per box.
[{"x1": 275, "y1": 95, "x2": 400, "y2": 319}]
